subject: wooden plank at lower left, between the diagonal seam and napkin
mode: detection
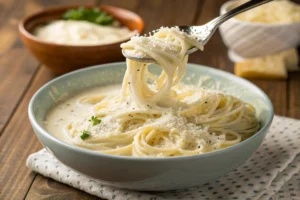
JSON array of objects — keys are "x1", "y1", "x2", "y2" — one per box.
[{"x1": 0, "y1": 67, "x2": 53, "y2": 199}]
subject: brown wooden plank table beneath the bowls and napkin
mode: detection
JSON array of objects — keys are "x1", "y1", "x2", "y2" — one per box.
[{"x1": 0, "y1": 0, "x2": 300, "y2": 200}]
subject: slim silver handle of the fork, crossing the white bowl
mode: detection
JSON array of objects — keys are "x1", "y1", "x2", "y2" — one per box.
[{"x1": 211, "y1": 0, "x2": 272, "y2": 27}]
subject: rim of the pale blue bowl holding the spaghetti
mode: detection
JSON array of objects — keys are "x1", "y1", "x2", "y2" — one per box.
[{"x1": 28, "y1": 62, "x2": 274, "y2": 162}]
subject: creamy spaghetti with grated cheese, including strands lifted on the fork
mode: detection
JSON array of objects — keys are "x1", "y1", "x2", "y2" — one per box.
[{"x1": 45, "y1": 28, "x2": 259, "y2": 157}]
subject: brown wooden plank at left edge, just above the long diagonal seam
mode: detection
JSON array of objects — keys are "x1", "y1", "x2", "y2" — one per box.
[{"x1": 0, "y1": 48, "x2": 38, "y2": 135}]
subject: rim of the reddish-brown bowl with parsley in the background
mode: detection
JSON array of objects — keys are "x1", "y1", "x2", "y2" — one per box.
[{"x1": 18, "y1": 5, "x2": 145, "y2": 48}]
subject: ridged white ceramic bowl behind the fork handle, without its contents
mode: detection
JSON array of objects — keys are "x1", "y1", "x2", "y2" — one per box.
[{"x1": 220, "y1": 1, "x2": 300, "y2": 58}]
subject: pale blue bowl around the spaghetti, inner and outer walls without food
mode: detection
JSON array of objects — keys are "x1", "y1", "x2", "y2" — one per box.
[{"x1": 28, "y1": 62, "x2": 273, "y2": 191}]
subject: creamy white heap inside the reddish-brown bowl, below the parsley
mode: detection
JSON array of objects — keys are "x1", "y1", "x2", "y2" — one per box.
[{"x1": 34, "y1": 20, "x2": 135, "y2": 45}]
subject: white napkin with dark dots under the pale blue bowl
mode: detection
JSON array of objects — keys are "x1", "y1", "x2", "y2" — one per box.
[{"x1": 27, "y1": 116, "x2": 300, "y2": 200}]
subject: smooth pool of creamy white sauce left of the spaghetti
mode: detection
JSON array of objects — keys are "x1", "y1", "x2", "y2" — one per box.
[{"x1": 44, "y1": 85, "x2": 121, "y2": 143}]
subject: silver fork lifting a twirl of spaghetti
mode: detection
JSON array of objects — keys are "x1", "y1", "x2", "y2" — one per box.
[{"x1": 122, "y1": 0, "x2": 272, "y2": 63}]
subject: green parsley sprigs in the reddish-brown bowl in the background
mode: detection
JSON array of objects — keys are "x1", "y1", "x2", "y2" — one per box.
[{"x1": 62, "y1": 7, "x2": 116, "y2": 26}]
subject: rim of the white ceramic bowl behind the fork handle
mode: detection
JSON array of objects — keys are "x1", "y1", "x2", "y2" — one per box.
[{"x1": 220, "y1": 0, "x2": 300, "y2": 28}]
